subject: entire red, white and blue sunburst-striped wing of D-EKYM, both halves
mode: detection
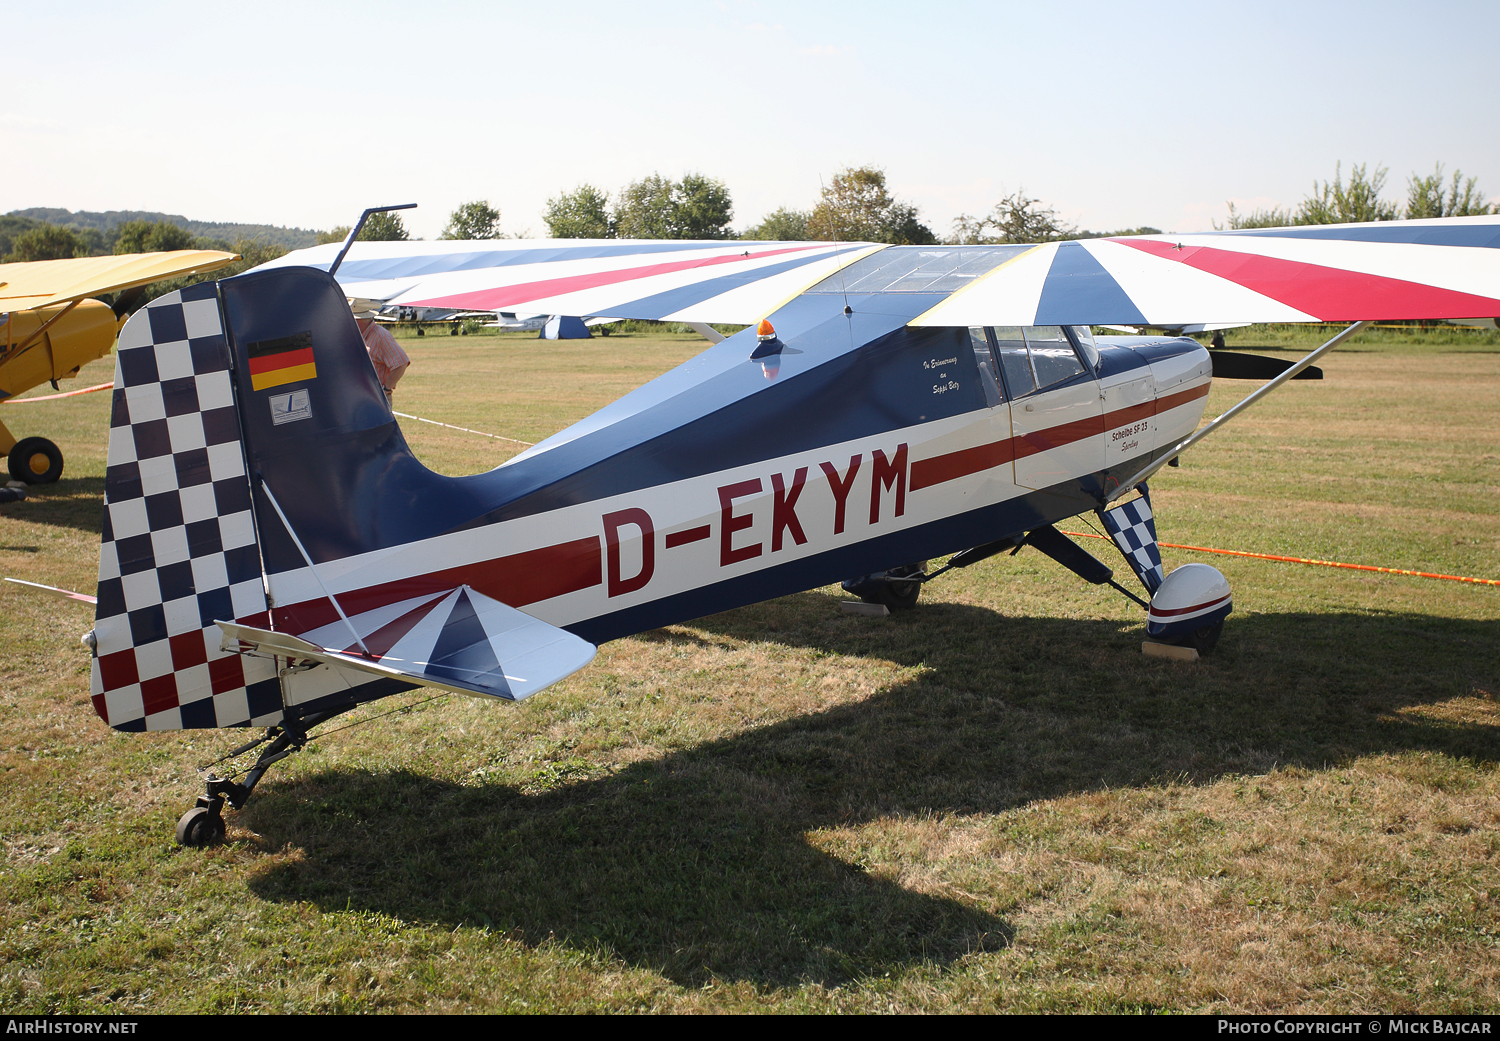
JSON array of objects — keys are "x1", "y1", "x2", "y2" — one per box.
[{"x1": 261, "y1": 216, "x2": 1500, "y2": 327}]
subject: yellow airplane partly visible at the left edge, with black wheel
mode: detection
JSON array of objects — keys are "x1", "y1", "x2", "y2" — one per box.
[{"x1": 0, "y1": 249, "x2": 239, "y2": 485}]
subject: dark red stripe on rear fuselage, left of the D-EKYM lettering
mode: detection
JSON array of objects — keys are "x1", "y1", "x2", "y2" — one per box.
[{"x1": 275, "y1": 536, "x2": 605, "y2": 633}]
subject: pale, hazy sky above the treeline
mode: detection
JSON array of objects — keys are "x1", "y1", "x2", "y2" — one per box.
[{"x1": 0, "y1": 0, "x2": 1500, "y2": 239}]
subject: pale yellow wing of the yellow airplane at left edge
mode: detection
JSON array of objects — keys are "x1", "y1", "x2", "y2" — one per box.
[{"x1": 0, "y1": 249, "x2": 240, "y2": 312}]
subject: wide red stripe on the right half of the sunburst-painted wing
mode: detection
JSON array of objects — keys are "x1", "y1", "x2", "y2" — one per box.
[{"x1": 1113, "y1": 239, "x2": 1500, "y2": 321}]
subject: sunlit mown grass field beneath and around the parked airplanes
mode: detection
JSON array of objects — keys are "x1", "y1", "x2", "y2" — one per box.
[{"x1": 0, "y1": 330, "x2": 1500, "y2": 1013}]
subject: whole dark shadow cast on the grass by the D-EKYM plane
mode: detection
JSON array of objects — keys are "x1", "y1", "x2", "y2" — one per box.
[{"x1": 246, "y1": 594, "x2": 1500, "y2": 986}]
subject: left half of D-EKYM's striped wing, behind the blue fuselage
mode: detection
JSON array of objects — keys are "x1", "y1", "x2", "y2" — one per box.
[{"x1": 252, "y1": 239, "x2": 884, "y2": 324}]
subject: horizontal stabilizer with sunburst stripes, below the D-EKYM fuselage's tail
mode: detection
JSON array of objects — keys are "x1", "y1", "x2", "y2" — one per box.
[{"x1": 216, "y1": 585, "x2": 596, "y2": 701}]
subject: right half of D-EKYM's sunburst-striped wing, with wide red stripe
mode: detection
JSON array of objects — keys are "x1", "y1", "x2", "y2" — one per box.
[{"x1": 912, "y1": 216, "x2": 1500, "y2": 327}]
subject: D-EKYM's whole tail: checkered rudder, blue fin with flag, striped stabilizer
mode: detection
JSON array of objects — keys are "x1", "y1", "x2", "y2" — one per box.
[{"x1": 93, "y1": 267, "x2": 597, "y2": 731}]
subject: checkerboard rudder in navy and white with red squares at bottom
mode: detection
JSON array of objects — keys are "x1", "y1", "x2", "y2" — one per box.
[{"x1": 92, "y1": 282, "x2": 282, "y2": 731}]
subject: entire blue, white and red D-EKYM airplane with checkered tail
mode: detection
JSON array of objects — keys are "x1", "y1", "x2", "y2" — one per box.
[{"x1": 58, "y1": 218, "x2": 1500, "y2": 843}]
